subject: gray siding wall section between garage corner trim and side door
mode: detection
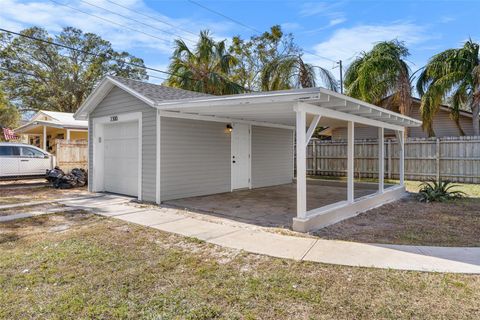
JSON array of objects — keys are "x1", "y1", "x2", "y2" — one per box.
[{"x1": 160, "y1": 117, "x2": 231, "y2": 201}]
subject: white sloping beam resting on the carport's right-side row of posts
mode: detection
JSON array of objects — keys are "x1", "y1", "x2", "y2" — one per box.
[{"x1": 295, "y1": 102, "x2": 405, "y2": 131}]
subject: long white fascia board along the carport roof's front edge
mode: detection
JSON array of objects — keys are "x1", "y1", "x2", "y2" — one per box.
[{"x1": 155, "y1": 92, "x2": 328, "y2": 110}]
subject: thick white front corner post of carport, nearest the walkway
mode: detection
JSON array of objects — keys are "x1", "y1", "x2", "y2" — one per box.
[{"x1": 296, "y1": 111, "x2": 307, "y2": 218}]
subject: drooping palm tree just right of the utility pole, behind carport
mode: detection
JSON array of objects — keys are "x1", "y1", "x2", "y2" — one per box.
[{"x1": 345, "y1": 40, "x2": 412, "y2": 121}]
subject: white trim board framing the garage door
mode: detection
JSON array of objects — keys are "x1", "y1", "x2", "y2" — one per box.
[{"x1": 92, "y1": 112, "x2": 143, "y2": 200}]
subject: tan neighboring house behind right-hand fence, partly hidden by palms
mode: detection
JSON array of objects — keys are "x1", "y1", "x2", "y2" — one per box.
[{"x1": 319, "y1": 97, "x2": 473, "y2": 140}]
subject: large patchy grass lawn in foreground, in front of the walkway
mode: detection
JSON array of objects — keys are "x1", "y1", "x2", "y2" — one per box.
[{"x1": 0, "y1": 212, "x2": 480, "y2": 319}]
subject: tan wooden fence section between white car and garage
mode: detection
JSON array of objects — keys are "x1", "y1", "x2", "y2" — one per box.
[{"x1": 53, "y1": 139, "x2": 88, "y2": 172}]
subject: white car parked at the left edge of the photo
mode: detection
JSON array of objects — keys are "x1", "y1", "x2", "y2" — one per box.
[{"x1": 0, "y1": 142, "x2": 55, "y2": 178}]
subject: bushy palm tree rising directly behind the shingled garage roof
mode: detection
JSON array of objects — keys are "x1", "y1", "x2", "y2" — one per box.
[{"x1": 167, "y1": 31, "x2": 245, "y2": 95}]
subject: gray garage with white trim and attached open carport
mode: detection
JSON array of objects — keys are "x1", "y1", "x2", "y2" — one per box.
[{"x1": 75, "y1": 76, "x2": 421, "y2": 231}]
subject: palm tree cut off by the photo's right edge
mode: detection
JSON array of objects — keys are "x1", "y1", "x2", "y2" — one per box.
[{"x1": 417, "y1": 40, "x2": 480, "y2": 136}]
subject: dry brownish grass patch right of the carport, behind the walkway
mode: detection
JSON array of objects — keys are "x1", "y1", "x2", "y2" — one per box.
[{"x1": 315, "y1": 195, "x2": 480, "y2": 247}]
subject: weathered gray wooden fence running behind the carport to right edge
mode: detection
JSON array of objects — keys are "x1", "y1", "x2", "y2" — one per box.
[{"x1": 307, "y1": 137, "x2": 480, "y2": 183}]
